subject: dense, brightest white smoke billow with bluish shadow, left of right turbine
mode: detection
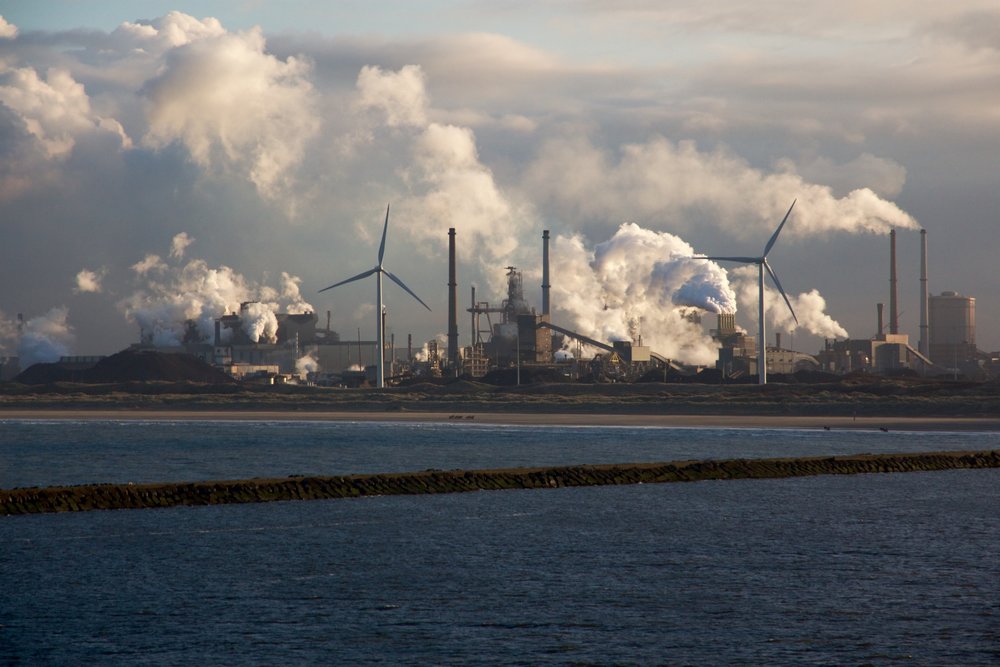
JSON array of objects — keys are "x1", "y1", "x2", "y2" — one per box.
[{"x1": 552, "y1": 223, "x2": 736, "y2": 364}]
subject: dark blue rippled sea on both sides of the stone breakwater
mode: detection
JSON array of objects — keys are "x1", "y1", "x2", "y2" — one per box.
[{"x1": 0, "y1": 421, "x2": 1000, "y2": 665}]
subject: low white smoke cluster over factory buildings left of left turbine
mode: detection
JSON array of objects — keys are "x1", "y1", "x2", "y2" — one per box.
[{"x1": 118, "y1": 234, "x2": 313, "y2": 347}]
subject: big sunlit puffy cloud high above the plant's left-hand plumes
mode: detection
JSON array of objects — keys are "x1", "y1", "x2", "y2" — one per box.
[{"x1": 143, "y1": 21, "x2": 320, "y2": 197}]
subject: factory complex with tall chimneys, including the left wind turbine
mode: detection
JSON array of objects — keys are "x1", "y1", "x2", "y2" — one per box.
[{"x1": 0, "y1": 223, "x2": 1000, "y2": 387}]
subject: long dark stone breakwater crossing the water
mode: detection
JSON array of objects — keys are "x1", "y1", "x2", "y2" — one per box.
[{"x1": 0, "y1": 450, "x2": 1000, "y2": 515}]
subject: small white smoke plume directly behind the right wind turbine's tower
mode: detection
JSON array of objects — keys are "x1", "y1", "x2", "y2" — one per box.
[{"x1": 729, "y1": 266, "x2": 848, "y2": 338}]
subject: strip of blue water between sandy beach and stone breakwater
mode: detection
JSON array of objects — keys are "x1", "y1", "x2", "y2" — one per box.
[{"x1": 0, "y1": 420, "x2": 1000, "y2": 488}]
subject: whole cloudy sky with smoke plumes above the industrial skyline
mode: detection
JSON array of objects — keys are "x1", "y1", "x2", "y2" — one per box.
[{"x1": 0, "y1": 0, "x2": 1000, "y2": 363}]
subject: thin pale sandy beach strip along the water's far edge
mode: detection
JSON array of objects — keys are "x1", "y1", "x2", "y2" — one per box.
[{"x1": 0, "y1": 408, "x2": 1000, "y2": 432}]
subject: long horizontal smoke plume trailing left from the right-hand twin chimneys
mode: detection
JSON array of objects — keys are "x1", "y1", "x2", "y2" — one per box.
[{"x1": 523, "y1": 137, "x2": 919, "y2": 238}]
